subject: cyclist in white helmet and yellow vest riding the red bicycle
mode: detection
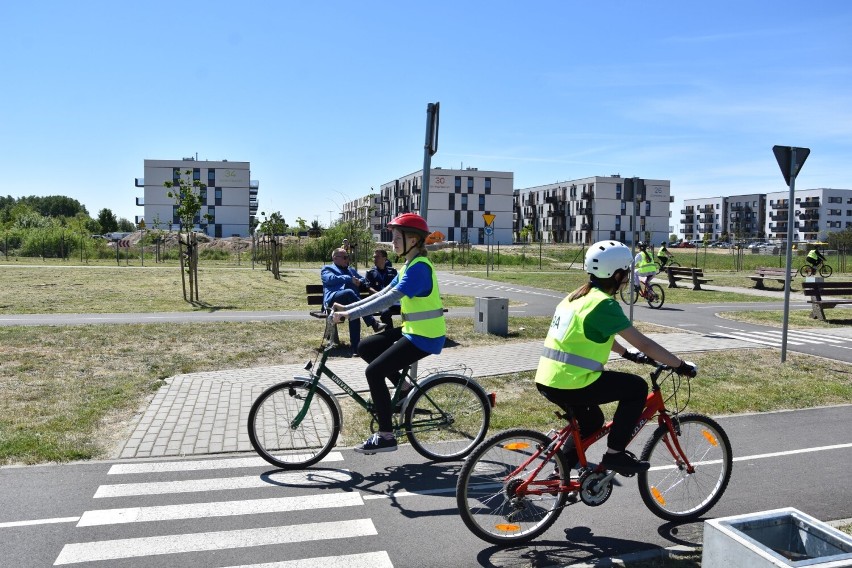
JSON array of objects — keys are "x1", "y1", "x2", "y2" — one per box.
[{"x1": 535, "y1": 241, "x2": 697, "y2": 475}]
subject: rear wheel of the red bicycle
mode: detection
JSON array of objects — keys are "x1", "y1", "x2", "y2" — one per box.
[{"x1": 456, "y1": 429, "x2": 570, "y2": 544}]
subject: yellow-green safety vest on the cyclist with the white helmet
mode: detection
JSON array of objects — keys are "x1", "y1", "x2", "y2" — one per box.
[{"x1": 535, "y1": 288, "x2": 615, "y2": 389}]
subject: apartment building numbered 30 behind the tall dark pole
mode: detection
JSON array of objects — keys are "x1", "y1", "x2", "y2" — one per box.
[{"x1": 362, "y1": 168, "x2": 514, "y2": 244}]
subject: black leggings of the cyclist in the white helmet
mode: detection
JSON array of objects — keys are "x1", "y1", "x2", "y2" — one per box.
[{"x1": 536, "y1": 371, "x2": 648, "y2": 451}]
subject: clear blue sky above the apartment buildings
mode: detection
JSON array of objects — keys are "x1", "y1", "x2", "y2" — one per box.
[{"x1": 0, "y1": 0, "x2": 852, "y2": 229}]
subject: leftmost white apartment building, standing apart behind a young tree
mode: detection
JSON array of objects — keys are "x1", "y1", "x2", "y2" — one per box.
[{"x1": 136, "y1": 158, "x2": 260, "y2": 237}]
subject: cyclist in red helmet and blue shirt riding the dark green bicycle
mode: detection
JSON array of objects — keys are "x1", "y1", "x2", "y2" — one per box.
[{"x1": 332, "y1": 213, "x2": 447, "y2": 454}]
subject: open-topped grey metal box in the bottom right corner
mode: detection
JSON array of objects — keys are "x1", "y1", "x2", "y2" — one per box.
[{"x1": 701, "y1": 507, "x2": 852, "y2": 568}]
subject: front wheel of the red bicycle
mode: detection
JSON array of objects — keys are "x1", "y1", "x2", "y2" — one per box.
[{"x1": 639, "y1": 414, "x2": 733, "y2": 521}]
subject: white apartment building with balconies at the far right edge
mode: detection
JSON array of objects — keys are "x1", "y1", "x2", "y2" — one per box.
[{"x1": 766, "y1": 188, "x2": 852, "y2": 241}]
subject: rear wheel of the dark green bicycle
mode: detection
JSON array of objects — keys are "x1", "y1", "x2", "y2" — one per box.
[{"x1": 404, "y1": 375, "x2": 491, "y2": 461}]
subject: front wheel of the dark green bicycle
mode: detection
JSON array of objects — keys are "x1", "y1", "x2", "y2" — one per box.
[{"x1": 248, "y1": 381, "x2": 340, "y2": 469}]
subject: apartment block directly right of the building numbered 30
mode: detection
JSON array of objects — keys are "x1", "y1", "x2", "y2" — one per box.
[{"x1": 513, "y1": 175, "x2": 673, "y2": 244}]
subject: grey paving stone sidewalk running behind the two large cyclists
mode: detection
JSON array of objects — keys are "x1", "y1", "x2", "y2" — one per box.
[{"x1": 114, "y1": 333, "x2": 755, "y2": 458}]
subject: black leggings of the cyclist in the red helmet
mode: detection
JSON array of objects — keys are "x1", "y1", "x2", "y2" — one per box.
[{"x1": 358, "y1": 327, "x2": 429, "y2": 432}]
